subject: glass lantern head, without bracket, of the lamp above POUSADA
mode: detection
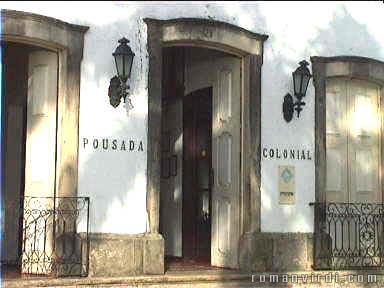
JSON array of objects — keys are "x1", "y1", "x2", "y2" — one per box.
[{"x1": 112, "y1": 38, "x2": 135, "y2": 82}]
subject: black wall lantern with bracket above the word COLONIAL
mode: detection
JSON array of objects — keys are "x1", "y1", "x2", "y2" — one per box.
[{"x1": 283, "y1": 60, "x2": 312, "y2": 122}]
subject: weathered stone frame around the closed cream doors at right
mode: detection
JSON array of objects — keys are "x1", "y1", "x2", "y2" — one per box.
[{"x1": 311, "y1": 56, "x2": 384, "y2": 202}]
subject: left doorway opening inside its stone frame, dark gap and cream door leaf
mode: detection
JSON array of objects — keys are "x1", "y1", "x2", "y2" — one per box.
[{"x1": 1, "y1": 41, "x2": 58, "y2": 274}]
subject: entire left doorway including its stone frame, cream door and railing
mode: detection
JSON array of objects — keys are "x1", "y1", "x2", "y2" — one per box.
[{"x1": 1, "y1": 9, "x2": 89, "y2": 275}]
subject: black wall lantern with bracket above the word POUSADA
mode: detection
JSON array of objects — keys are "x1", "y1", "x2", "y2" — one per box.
[{"x1": 108, "y1": 37, "x2": 135, "y2": 109}]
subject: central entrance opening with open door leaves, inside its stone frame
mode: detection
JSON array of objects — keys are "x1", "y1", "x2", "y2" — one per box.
[{"x1": 160, "y1": 47, "x2": 241, "y2": 268}]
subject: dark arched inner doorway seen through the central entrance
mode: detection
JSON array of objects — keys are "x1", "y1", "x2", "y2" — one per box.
[{"x1": 182, "y1": 87, "x2": 212, "y2": 263}]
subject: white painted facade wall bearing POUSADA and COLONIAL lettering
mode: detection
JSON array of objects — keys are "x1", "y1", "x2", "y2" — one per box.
[{"x1": 0, "y1": 1, "x2": 384, "y2": 233}]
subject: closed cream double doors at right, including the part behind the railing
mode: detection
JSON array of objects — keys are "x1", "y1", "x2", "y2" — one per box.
[{"x1": 326, "y1": 79, "x2": 382, "y2": 266}]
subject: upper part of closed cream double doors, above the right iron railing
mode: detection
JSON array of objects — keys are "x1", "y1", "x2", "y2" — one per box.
[{"x1": 326, "y1": 79, "x2": 382, "y2": 203}]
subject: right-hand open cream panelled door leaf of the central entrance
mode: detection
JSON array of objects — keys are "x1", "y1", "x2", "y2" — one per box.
[{"x1": 211, "y1": 56, "x2": 241, "y2": 268}]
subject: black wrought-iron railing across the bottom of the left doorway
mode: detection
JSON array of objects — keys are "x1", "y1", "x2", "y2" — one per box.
[{"x1": 15, "y1": 197, "x2": 89, "y2": 277}]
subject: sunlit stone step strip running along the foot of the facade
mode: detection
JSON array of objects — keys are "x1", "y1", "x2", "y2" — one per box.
[{"x1": 3, "y1": 269, "x2": 384, "y2": 288}]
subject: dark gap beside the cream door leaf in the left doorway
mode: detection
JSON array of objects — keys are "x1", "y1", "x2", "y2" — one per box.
[{"x1": 1, "y1": 42, "x2": 28, "y2": 263}]
